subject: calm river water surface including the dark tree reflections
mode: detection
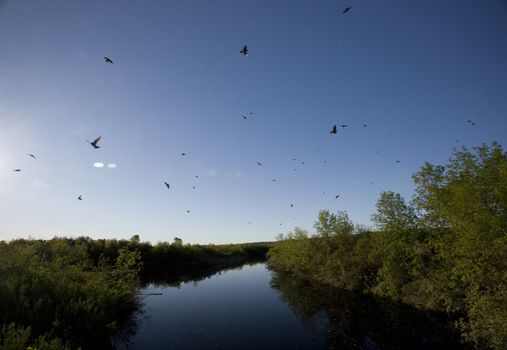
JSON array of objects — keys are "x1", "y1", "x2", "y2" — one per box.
[{"x1": 124, "y1": 264, "x2": 463, "y2": 350}]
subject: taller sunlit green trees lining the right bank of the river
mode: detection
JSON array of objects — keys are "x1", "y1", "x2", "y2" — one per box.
[{"x1": 268, "y1": 143, "x2": 507, "y2": 349}]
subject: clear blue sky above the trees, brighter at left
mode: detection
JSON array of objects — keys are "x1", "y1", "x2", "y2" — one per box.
[{"x1": 0, "y1": 0, "x2": 507, "y2": 243}]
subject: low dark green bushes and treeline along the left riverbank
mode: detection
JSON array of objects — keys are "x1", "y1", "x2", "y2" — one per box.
[{"x1": 0, "y1": 236, "x2": 272, "y2": 350}]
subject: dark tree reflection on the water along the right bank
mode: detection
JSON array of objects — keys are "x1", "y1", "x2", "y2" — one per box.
[{"x1": 270, "y1": 272, "x2": 469, "y2": 349}]
